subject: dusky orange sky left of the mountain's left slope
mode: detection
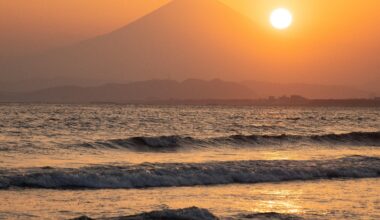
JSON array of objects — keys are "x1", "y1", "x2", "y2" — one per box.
[{"x1": 0, "y1": 0, "x2": 168, "y2": 55}]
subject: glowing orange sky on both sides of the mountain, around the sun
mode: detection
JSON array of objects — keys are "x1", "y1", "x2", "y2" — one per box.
[{"x1": 0, "y1": 0, "x2": 380, "y2": 90}]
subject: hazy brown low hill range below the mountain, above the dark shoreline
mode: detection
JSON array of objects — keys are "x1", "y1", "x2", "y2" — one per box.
[{"x1": 0, "y1": 79, "x2": 370, "y2": 103}]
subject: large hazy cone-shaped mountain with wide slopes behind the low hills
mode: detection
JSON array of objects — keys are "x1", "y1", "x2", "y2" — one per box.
[{"x1": 0, "y1": 0, "x2": 380, "y2": 93}]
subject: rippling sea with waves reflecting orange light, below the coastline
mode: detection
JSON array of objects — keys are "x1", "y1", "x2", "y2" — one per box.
[{"x1": 0, "y1": 104, "x2": 380, "y2": 219}]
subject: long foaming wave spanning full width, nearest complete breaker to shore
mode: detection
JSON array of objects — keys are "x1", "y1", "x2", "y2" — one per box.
[{"x1": 0, "y1": 156, "x2": 380, "y2": 189}]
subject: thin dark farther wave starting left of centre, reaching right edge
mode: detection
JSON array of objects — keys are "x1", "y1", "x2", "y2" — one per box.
[{"x1": 80, "y1": 132, "x2": 380, "y2": 151}]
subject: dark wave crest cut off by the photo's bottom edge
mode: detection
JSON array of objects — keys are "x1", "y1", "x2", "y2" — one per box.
[{"x1": 72, "y1": 207, "x2": 302, "y2": 220}]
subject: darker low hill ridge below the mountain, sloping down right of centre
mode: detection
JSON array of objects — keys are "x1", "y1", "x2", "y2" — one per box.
[{"x1": 0, "y1": 79, "x2": 257, "y2": 103}]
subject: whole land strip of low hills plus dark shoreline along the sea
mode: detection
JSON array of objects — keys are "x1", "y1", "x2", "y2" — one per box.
[{"x1": 0, "y1": 79, "x2": 374, "y2": 106}]
